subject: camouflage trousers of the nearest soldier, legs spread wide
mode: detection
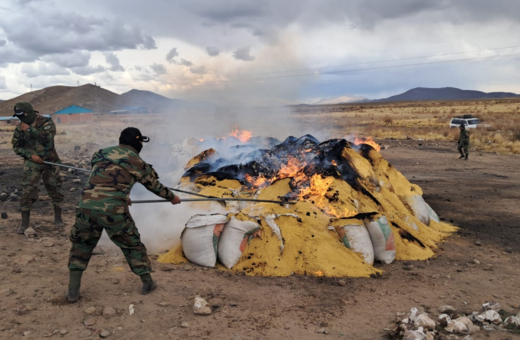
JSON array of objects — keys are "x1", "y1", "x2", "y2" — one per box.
[{"x1": 69, "y1": 208, "x2": 152, "y2": 276}]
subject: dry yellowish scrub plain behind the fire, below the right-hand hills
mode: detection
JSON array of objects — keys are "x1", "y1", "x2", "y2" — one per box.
[{"x1": 294, "y1": 99, "x2": 520, "y2": 154}]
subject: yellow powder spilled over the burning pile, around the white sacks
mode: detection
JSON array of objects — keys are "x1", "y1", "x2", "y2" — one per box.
[{"x1": 159, "y1": 143, "x2": 457, "y2": 277}]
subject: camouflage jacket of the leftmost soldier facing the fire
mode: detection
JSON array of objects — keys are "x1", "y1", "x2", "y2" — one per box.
[{"x1": 11, "y1": 115, "x2": 60, "y2": 166}]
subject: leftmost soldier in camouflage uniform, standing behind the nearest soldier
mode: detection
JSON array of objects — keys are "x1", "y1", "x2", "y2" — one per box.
[{"x1": 12, "y1": 102, "x2": 63, "y2": 234}]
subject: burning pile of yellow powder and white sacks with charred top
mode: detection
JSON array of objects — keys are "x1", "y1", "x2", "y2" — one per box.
[{"x1": 159, "y1": 135, "x2": 455, "y2": 276}]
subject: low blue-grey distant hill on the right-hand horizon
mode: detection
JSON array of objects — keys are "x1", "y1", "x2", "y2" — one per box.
[{"x1": 377, "y1": 87, "x2": 520, "y2": 101}]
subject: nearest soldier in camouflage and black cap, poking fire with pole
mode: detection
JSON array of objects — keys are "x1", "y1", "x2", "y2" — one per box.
[{"x1": 67, "y1": 128, "x2": 181, "y2": 302}]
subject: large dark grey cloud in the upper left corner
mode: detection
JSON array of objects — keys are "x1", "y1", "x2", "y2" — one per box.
[{"x1": 0, "y1": 6, "x2": 157, "y2": 63}]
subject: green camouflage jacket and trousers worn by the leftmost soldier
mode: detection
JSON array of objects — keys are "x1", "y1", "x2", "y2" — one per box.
[{"x1": 11, "y1": 115, "x2": 63, "y2": 211}]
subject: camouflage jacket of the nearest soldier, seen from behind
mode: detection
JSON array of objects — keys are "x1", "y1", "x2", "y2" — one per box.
[{"x1": 78, "y1": 145, "x2": 175, "y2": 213}]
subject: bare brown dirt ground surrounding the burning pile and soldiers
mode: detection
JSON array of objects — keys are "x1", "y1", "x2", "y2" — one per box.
[{"x1": 0, "y1": 134, "x2": 520, "y2": 340}]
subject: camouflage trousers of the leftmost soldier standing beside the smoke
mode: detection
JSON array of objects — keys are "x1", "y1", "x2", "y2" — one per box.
[{"x1": 20, "y1": 161, "x2": 63, "y2": 211}]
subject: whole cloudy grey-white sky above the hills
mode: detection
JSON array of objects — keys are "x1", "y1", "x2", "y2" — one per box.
[{"x1": 0, "y1": 0, "x2": 520, "y2": 105}]
